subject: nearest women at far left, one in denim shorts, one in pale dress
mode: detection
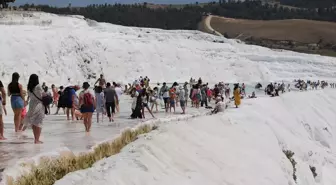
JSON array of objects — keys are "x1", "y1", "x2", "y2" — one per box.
[{"x1": 0, "y1": 72, "x2": 45, "y2": 144}]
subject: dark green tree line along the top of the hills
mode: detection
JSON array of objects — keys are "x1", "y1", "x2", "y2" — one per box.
[{"x1": 21, "y1": 0, "x2": 336, "y2": 30}]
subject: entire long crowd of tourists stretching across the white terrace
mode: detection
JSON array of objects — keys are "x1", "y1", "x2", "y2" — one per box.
[{"x1": 0, "y1": 73, "x2": 335, "y2": 144}]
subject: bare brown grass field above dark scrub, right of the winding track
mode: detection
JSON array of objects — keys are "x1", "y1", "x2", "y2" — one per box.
[{"x1": 211, "y1": 17, "x2": 336, "y2": 43}]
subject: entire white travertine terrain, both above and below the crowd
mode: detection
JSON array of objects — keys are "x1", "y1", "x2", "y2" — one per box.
[{"x1": 0, "y1": 12, "x2": 336, "y2": 185}]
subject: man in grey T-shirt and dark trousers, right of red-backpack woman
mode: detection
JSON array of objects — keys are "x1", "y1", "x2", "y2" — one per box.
[{"x1": 104, "y1": 82, "x2": 119, "y2": 122}]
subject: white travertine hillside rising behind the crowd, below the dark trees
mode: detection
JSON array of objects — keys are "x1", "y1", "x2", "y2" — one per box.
[{"x1": 0, "y1": 12, "x2": 336, "y2": 84}]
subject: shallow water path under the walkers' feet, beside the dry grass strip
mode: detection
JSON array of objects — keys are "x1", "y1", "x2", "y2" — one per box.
[{"x1": 0, "y1": 95, "x2": 214, "y2": 177}]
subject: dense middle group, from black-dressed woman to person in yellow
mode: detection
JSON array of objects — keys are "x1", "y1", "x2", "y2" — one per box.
[{"x1": 126, "y1": 77, "x2": 245, "y2": 119}]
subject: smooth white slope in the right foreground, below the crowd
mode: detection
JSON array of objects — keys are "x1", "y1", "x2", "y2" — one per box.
[{"x1": 55, "y1": 89, "x2": 336, "y2": 185}]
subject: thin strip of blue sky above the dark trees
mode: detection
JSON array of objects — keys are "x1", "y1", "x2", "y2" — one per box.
[{"x1": 13, "y1": 0, "x2": 210, "y2": 6}]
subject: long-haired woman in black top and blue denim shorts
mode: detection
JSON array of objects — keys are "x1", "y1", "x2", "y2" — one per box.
[{"x1": 8, "y1": 72, "x2": 25, "y2": 132}]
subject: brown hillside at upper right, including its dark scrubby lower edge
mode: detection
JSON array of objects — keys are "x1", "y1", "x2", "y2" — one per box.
[{"x1": 211, "y1": 16, "x2": 336, "y2": 56}]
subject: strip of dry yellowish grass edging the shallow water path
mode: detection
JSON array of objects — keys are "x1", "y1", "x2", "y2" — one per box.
[{"x1": 8, "y1": 125, "x2": 157, "y2": 185}]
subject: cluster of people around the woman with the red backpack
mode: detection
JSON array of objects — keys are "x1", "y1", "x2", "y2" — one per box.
[{"x1": 52, "y1": 75, "x2": 123, "y2": 129}]
